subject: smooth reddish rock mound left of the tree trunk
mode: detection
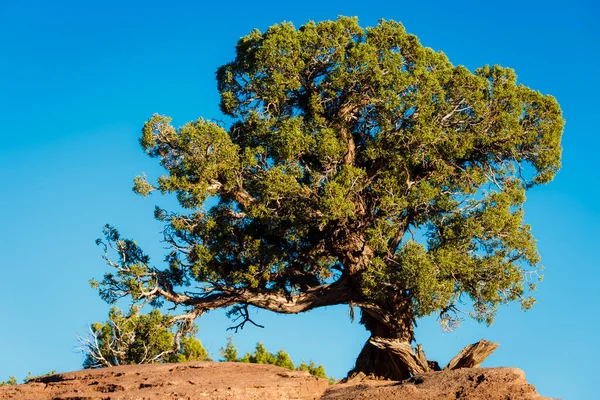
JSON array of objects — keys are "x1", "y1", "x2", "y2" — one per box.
[{"x1": 0, "y1": 362, "x2": 329, "y2": 400}]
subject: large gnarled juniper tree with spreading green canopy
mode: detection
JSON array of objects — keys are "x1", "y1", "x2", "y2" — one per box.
[{"x1": 92, "y1": 17, "x2": 563, "y2": 379}]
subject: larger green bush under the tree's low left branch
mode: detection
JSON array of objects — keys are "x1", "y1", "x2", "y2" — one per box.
[{"x1": 81, "y1": 307, "x2": 210, "y2": 368}]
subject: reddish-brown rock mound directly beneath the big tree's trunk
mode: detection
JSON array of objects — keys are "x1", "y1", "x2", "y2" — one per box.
[{"x1": 321, "y1": 368, "x2": 548, "y2": 400}]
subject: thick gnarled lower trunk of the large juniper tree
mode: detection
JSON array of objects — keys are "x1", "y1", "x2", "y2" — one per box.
[{"x1": 348, "y1": 308, "x2": 414, "y2": 381}]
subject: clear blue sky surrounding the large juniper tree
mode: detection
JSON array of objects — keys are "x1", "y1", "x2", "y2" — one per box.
[{"x1": 0, "y1": 0, "x2": 600, "y2": 399}]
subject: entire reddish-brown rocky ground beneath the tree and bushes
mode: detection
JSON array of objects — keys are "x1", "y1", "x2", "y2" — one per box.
[{"x1": 0, "y1": 362, "x2": 546, "y2": 400}]
